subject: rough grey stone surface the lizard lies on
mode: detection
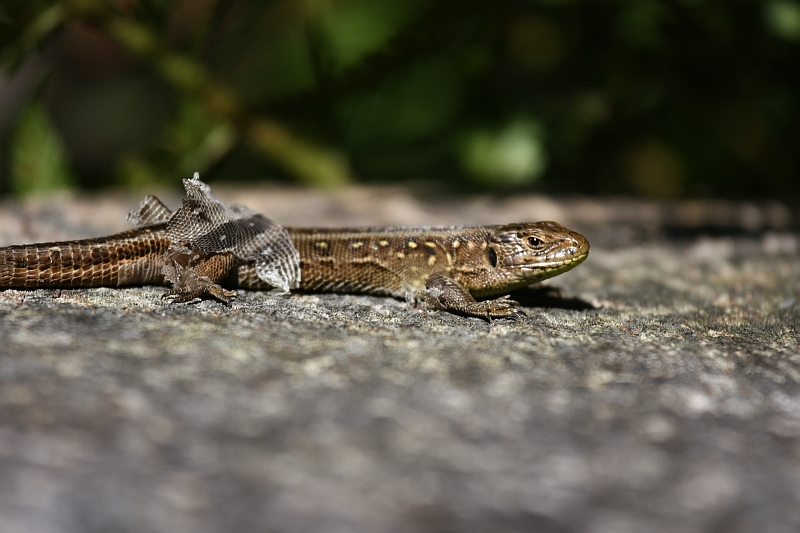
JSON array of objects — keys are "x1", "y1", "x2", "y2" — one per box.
[{"x1": 0, "y1": 187, "x2": 800, "y2": 533}]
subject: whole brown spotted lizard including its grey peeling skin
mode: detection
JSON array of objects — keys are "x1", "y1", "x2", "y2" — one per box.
[{"x1": 0, "y1": 176, "x2": 589, "y2": 321}]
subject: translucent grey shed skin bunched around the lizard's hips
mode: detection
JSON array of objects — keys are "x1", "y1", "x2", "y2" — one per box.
[{"x1": 128, "y1": 173, "x2": 300, "y2": 293}]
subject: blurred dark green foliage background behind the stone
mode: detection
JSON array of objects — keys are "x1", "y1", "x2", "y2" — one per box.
[{"x1": 0, "y1": 0, "x2": 800, "y2": 199}]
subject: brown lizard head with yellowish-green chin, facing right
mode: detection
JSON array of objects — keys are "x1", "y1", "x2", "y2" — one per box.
[{"x1": 488, "y1": 220, "x2": 589, "y2": 294}]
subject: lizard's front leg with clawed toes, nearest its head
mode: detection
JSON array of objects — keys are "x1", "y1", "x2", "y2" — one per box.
[{"x1": 407, "y1": 274, "x2": 525, "y2": 322}]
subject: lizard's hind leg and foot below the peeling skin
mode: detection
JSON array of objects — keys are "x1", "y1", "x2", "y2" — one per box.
[{"x1": 162, "y1": 245, "x2": 237, "y2": 305}]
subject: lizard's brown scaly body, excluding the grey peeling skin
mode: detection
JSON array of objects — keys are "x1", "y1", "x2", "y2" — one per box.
[{"x1": 0, "y1": 221, "x2": 589, "y2": 319}]
